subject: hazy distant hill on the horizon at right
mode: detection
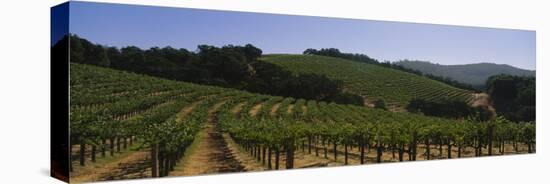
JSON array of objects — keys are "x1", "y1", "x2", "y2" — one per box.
[{"x1": 395, "y1": 60, "x2": 535, "y2": 88}]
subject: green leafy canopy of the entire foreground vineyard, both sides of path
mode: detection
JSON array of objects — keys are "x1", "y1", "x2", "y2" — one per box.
[{"x1": 70, "y1": 63, "x2": 536, "y2": 172}]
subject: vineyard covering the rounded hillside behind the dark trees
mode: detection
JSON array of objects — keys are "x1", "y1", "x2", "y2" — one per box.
[{"x1": 262, "y1": 54, "x2": 472, "y2": 107}]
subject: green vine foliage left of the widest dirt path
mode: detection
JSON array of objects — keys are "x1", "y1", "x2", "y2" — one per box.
[{"x1": 69, "y1": 64, "x2": 224, "y2": 171}]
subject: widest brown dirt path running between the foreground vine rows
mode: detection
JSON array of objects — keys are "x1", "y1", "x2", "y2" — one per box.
[{"x1": 170, "y1": 102, "x2": 245, "y2": 176}]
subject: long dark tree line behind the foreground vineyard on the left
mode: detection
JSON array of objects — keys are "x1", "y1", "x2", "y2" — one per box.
[{"x1": 52, "y1": 35, "x2": 363, "y2": 105}]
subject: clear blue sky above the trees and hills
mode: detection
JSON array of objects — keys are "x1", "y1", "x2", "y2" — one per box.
[{"x1": 70, "y1": 2, "x2": 535, "y2": 70}]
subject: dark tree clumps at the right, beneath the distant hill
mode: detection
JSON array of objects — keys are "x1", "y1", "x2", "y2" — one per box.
[{"x1": 406, "y1": 74, "x2": 536, "y2": 122}]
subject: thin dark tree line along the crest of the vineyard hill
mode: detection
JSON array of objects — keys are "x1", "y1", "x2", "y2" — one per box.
[{"x1": 303, "y1": 48, "x2": 479, "y2": 91}]
